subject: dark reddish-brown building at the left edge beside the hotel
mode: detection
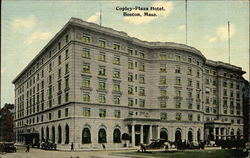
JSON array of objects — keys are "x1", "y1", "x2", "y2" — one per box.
[{"x1": 0, "y1": 104, "x2": 15, "y2": 142}]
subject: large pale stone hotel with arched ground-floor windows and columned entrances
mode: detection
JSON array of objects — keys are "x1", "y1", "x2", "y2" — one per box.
[{"x1": 13, "y1": 18, "x2": 245, "y2": 150}]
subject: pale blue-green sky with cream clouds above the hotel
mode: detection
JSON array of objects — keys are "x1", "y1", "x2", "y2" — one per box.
[{"x1": 1, "y1": 0, "x2": 249, "y2": 106}]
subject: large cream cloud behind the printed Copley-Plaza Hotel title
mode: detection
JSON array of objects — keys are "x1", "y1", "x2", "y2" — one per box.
[{"x1": 124, "y1": 1, "x2": 173, "y2": 25}]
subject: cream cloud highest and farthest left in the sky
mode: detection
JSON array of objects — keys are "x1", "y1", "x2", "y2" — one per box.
[{"x1": 11, "y1": 16, "x2": 37, "y2": 29}]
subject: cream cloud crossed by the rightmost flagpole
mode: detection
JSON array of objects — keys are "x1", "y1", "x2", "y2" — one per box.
[{"x1": 203, "y1": 24, "x2": 235, "y2": 43}]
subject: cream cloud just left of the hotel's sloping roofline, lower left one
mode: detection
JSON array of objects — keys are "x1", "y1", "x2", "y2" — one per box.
[{"x1": 24, "y1": 30, "x2": 51, "y2": 45}]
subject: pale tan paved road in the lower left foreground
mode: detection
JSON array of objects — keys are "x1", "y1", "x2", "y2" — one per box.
[{"x1": 0, "y1": 146, "x2": 143, "y2": 158}]
